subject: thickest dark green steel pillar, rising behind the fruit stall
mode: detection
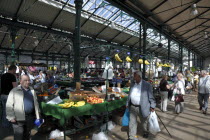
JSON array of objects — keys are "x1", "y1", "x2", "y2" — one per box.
[{"x1": 73, "y1": 0, "x2": 83, "y2": 82}]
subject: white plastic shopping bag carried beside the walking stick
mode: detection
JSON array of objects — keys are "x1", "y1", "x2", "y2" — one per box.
[{"x1": 149, "y1": 111, "x2": 160, "y2": 133}]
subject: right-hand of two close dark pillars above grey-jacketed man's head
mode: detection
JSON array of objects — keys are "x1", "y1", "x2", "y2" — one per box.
[{"x1": 142, "y1": 23, "x2": 147, "y2": 79}]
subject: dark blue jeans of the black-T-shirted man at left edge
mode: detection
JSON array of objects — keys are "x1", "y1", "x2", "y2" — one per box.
[{"x1": 0, "y1": 95, "x2": 12, "y2": 128}]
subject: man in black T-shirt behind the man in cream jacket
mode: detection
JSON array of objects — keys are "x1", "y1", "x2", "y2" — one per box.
[{"x1": 0, "y1": 65, "x2": 17, "y2": 127}]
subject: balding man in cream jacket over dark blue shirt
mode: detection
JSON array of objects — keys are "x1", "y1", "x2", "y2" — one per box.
[{"x1": 6, "y1": 75, "x2": 39, "y2": 140}]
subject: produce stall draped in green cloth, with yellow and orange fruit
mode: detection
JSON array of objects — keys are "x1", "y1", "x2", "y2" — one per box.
[{"x1": 38, "y1": 84, "x2": 128, "y2": 139}]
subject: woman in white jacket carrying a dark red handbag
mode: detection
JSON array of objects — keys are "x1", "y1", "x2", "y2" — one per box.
[{"x1": 173, "y1": 73, "x2": 185, "y2": 114}]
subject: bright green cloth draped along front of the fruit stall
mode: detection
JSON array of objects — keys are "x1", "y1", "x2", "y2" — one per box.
[{"x1": 40, "y1": 97, "x2": 127, "y2": 126}]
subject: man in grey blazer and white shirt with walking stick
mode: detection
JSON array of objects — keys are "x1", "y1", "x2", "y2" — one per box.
[{"x1": 126, "y1": 71, "x2": 156, "y2": 140}]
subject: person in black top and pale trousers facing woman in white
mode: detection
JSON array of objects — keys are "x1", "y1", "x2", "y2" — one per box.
[{"x1": 159, "y1": 75, "x2": 170, "y2": 112}]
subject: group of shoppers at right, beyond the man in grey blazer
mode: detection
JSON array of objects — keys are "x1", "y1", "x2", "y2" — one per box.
[{"x1": 159, "y1": 70, "x2": 210, "y2": 114}]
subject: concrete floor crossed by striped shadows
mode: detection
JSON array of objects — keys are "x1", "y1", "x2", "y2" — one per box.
[{"x1": 0, "y1": 93, "x2": 210, "y2": 140}]
